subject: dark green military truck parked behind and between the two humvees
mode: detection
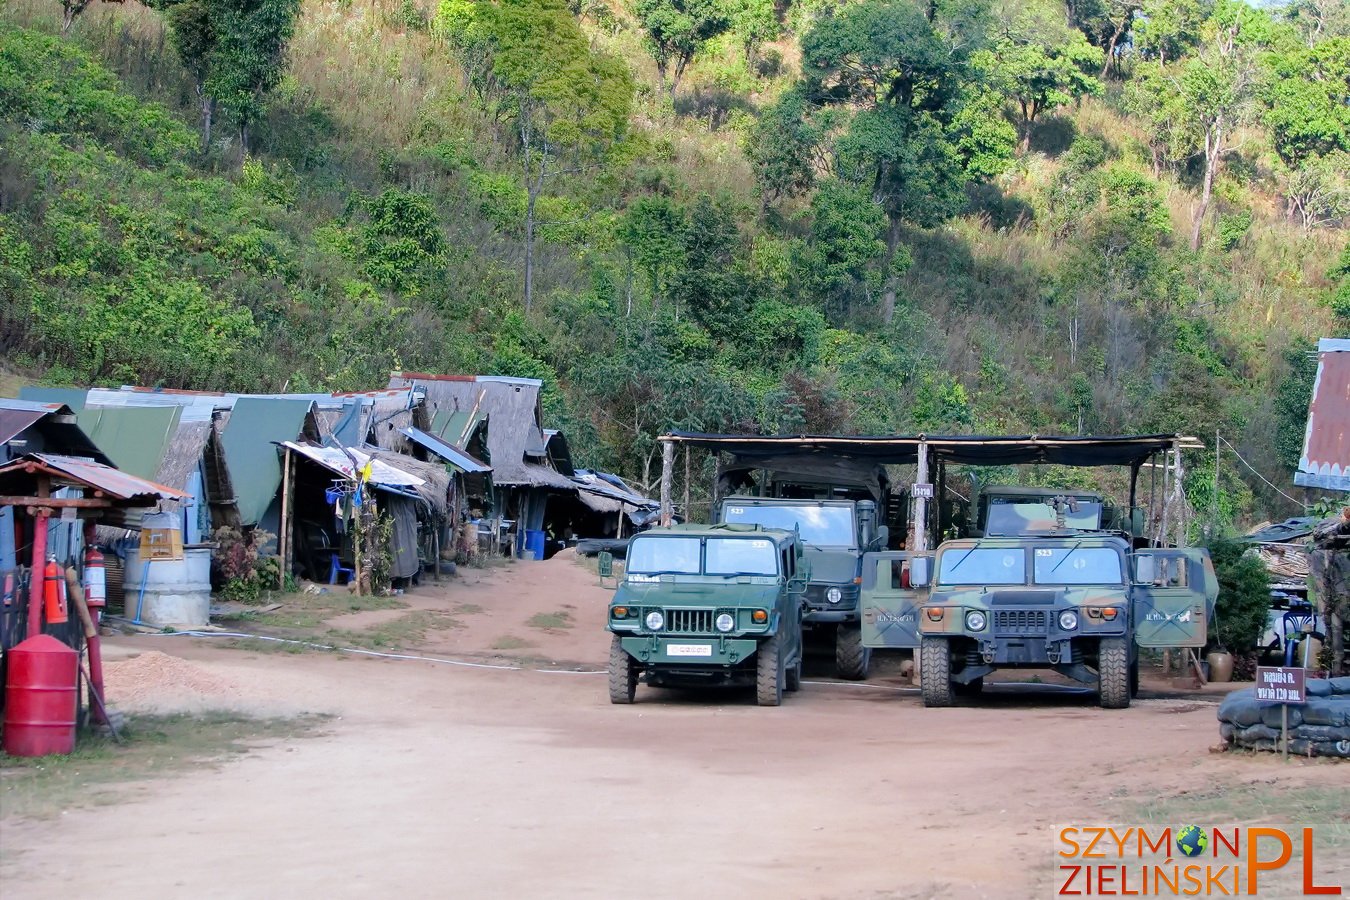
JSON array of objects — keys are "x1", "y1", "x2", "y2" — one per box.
[{"x1": 717, "y1": 497, "x2": 888, "y2": 680}]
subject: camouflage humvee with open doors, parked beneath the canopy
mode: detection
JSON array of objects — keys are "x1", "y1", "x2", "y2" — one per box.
[{"x1": 918, "y1": 530, "x2": 1218, "y2": 708}]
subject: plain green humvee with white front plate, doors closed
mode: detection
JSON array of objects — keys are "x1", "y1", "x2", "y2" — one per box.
[{"x1": 608, "y1": 525, "x2": 810, "y2": 706}]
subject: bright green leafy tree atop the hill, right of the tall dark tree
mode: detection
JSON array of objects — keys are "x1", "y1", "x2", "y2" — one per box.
[{"x1": 981, "y1": 0, "x2": 1103, "y2": 152}]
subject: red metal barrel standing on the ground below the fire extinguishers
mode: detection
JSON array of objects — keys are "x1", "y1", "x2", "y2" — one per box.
[{"x1": 4, "y1": 634, "x2": 80, "y2": 756}]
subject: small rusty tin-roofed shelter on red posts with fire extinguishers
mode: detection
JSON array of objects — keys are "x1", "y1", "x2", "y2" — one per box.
[{"x1": 0, "y1": 453, "x2": 186, "y2": 646}]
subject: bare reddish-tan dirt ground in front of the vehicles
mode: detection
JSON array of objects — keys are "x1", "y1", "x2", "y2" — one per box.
[{"x1": 0, "y1": 559, "x2": 1350, "y2": 900}]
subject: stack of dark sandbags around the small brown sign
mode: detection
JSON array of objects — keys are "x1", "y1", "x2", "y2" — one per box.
[{"x1": 1219, "y1": 677, "x2": 1350, "y2": 758}]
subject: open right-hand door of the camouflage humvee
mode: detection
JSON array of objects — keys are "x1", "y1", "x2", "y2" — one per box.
[{"x1": 1130, "y1": 549, "x2": 1219, "y2": 648}]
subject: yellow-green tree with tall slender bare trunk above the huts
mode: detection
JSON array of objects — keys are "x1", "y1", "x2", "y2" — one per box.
[{"x1": 440, "y1": 0, "x2": 633, "y2": 309}]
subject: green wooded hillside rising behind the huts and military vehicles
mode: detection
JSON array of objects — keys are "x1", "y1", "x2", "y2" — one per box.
[{"x1": 0, "y1": 0, "x2": 1350, "y2": 522}]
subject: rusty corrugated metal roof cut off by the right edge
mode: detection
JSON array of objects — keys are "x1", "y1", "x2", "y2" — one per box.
[{"x1": 1293, "y1": 337, "x2": 1350, "y2": 491}]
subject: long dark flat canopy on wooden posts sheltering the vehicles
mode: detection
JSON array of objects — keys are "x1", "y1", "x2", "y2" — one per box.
[{"x1": 660, "y1": 432, "x2": 1204, "y2": 549}]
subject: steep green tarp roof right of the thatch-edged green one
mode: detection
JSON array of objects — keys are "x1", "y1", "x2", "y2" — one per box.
[{"x1": 220, "y1": 397, "x2": 313, "y2": 525}]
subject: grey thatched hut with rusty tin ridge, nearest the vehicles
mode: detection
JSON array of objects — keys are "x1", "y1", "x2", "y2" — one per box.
[{"x1": 389, "y1": 372, "x2": 578, "y2": 555}]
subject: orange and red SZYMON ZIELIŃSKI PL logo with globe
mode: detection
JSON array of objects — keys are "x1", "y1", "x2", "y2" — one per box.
[{"x1": 1054, "y1": 824, "x2": 1342, "y2": 897}]
